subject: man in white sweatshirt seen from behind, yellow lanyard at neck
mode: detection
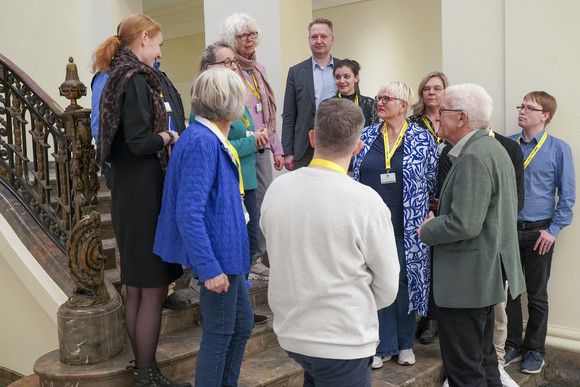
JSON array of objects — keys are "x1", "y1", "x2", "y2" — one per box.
[{"x1": 260, "y1": 98, "x2": 399, "y2": 387}]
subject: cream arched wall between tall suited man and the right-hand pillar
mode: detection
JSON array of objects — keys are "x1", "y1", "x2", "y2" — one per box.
[{"x1": 314, "y1": 0, "x2": 442, "y2": 104}]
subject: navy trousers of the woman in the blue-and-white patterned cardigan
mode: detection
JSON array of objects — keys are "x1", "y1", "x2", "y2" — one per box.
[{"x1": 377, "y1": 236, "x2": 415, "y2": 356}]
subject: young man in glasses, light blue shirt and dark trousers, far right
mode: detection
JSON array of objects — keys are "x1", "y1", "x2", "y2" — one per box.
[{"x1": 505, "y1": 91, "x2": 576, "y2": 374}]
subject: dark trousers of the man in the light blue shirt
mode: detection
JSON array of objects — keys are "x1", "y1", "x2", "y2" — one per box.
[{"x1": 506, "y1": 229, "x2": 556, "y2": 354}]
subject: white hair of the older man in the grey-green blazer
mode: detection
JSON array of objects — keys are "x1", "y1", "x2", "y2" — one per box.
[{"x1": 445, "y1": 83, "x2": 493, "y2": 129}]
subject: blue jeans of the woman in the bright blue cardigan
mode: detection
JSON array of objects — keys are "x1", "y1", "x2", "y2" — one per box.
[{"x1": 195, "y1": 274, "x2": 254, "y2": 387}]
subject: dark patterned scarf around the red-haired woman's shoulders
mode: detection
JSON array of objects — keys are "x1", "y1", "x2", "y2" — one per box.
[{"x1": 97, "y1": 46, "x2": 169, "y2": 173}]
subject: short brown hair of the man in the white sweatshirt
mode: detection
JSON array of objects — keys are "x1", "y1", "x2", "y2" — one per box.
[{"x1": 314, "y1": 98, "x2": 365, "y2": 155}]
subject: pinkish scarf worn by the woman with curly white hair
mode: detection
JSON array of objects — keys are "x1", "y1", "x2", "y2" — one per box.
[{"x1": 236, "y1": 52, "x2": 276, "y2": 140}]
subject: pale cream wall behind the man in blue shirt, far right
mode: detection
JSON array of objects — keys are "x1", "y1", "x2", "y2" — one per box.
[{"x1": 442, "y1": 0, "x2": 580, "y2": 351}]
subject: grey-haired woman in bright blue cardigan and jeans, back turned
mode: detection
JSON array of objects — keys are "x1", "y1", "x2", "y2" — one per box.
[{"x1": 154, "y1": 66, "x2": 253, "y2": 387}]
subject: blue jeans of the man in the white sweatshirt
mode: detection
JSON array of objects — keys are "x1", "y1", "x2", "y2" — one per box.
[{"x1": 286, "y1": 351, "x2": 372, "y2": 387}]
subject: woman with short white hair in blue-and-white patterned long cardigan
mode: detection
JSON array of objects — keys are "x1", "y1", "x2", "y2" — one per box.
[{"x1": 353, "y1": 81, "x2": 439, "y2": 368}]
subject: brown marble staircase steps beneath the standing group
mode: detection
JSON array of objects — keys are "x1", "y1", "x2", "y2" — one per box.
[{"x1": 5, "y1": 177, "x2": 568, "y2": 387}]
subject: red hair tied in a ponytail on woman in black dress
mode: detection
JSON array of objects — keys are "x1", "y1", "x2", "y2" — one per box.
[{"x1": 92, "y1": 13, "x2": 161, "y2": 73}]
